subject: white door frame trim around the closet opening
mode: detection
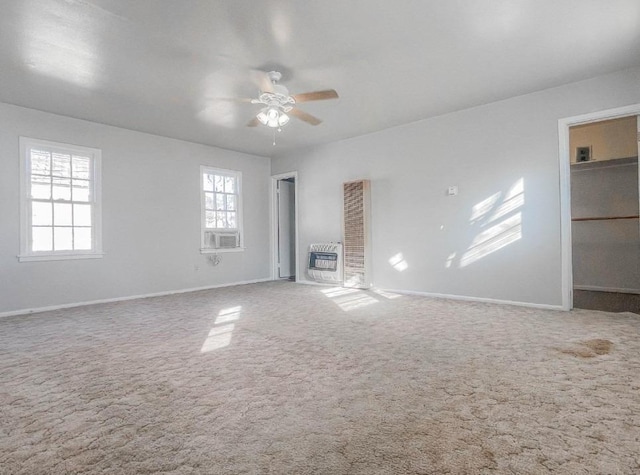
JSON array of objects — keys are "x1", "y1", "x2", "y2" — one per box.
[{"x1": 558, "y1": 104, "x2": 640, "y2": 310}]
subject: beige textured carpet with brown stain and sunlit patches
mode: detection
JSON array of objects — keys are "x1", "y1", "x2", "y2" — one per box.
[{"x1": 0, "y1": 282, "x2": 640, "y2": 475}]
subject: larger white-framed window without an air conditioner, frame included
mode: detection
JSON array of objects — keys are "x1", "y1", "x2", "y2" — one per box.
[{"x1": 18, "y1": 137, "x2": 103, "y2": 261}]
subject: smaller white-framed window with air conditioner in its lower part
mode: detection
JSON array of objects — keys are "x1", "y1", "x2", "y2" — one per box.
[{"x1": 200, "y1": 166, "x2": 243, "y2": 252}]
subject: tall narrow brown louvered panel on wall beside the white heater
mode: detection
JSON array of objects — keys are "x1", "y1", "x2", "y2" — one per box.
[{"x1": 343, "y1": 180, "x2": 371, "y2": 289}]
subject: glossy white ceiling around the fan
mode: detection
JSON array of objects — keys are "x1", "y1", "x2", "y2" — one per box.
[{"x1": 0, "y1": 0, "x2": 640, "y2": 156}]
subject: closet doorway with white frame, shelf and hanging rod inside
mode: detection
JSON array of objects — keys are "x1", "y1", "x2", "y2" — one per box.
[{"x1": 560, "y1": 109, "x2": 640, "y2": 313}]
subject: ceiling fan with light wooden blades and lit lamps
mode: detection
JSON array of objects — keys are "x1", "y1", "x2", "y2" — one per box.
[{"x1": 244, "y1": 71, "x2": 338, "y2": 130}]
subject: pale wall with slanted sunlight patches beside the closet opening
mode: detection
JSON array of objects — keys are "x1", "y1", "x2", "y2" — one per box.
[{"x1": 271, "y1": 69, "x2": 640, "y2": 306}]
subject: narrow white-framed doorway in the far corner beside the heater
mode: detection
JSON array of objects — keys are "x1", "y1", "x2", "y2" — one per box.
[{"x1": 271, "y1": 172, "x2": 298, "y2": 282}]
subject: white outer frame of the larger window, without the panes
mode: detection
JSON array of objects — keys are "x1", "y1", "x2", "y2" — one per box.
[{"x1": 18, "y1": 137, "x2": 104, "y2": 262}]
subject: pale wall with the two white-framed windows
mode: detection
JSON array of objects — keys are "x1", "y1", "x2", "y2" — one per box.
[{"x1": 0, "y1": 104, "x2": 270, "y2": 314}]
